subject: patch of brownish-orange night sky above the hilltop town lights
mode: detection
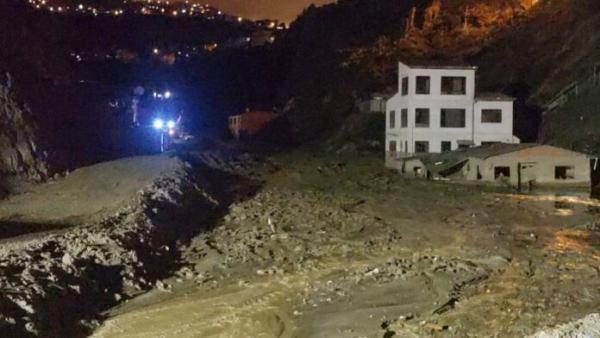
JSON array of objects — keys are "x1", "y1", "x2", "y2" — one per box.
[{"x1": 202, "y1": 0, "x2": 334, "y2": 22}]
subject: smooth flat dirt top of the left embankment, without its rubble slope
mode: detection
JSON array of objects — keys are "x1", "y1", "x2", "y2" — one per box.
[{"x1": 0, "y1": 156, "x2": 181, "y2": 238}]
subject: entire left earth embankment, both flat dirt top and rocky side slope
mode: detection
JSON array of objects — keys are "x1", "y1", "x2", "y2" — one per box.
[{"x1": 0, "y1": 152, "x2": 268, "y2": 337}]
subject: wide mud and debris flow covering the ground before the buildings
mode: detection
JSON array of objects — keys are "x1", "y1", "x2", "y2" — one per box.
[{"x1": 93, "y1": 152, "x2": 600, "y2": 338}]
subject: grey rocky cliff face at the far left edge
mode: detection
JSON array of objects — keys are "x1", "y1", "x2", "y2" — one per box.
[{"x1": 0, "y1": 74, "x2": 47, "y2": 180}]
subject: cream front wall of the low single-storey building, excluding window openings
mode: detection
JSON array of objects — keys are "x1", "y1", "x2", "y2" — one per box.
[{"x1": 463, "y1": 146, "x2": 591, "y2": 187}]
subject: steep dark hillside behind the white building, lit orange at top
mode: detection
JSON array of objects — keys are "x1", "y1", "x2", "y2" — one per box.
[{"x1": 282, "y1": 0, "x2": 600, "y2": 146}]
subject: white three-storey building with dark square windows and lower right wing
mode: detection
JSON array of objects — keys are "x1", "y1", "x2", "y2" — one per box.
[{"x1": 386, "y1": 63, "x2": 519, "y2": 157}]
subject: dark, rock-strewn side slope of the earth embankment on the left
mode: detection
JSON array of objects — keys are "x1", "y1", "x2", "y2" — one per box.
[{"x1": 0, "y1": 160, "x2": 215, "y2": 337}]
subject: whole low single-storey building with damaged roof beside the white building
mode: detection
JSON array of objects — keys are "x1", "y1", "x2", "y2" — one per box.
[{"x1": 386, "y1": 143, "x2": 591, "y2": 188}]
